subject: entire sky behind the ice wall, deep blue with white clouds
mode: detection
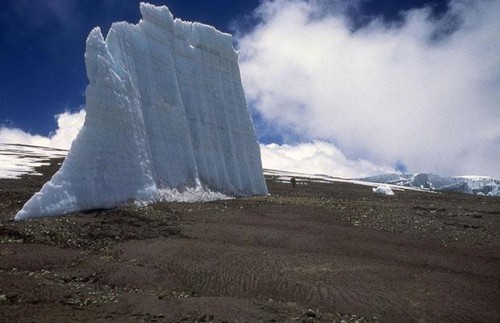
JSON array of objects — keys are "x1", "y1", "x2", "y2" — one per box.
[{"x1": 0, "y1": 0, "x2": 500, "y2": 177}]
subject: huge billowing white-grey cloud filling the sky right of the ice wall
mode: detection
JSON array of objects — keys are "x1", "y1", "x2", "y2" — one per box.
[{"x1": 238, "y1": 0, "x2": 500, "y2": 177}]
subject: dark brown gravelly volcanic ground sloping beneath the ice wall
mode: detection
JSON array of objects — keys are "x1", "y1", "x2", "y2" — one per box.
[{"x1": 0, "y1": 160, "x2": 500, "y2": 322}]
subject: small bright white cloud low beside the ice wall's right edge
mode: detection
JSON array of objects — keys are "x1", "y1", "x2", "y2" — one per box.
[{"x1": 260, "y1": 141, "x2": 397, "y2": 178}]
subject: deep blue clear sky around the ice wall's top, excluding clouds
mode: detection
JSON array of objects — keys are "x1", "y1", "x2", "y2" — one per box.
[{"x1": 0, "y1": 0, "x2": 443, "y2": 135}]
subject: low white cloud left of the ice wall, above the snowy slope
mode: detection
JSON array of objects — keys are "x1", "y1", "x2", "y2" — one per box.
[{"x1": 0, "y1": 109, "x2": 85, "y2": 149}]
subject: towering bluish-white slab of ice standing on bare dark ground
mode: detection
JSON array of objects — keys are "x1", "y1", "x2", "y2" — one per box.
[{"x1": 15, "y1": 3, "x2": 267, "y2": 220}]
